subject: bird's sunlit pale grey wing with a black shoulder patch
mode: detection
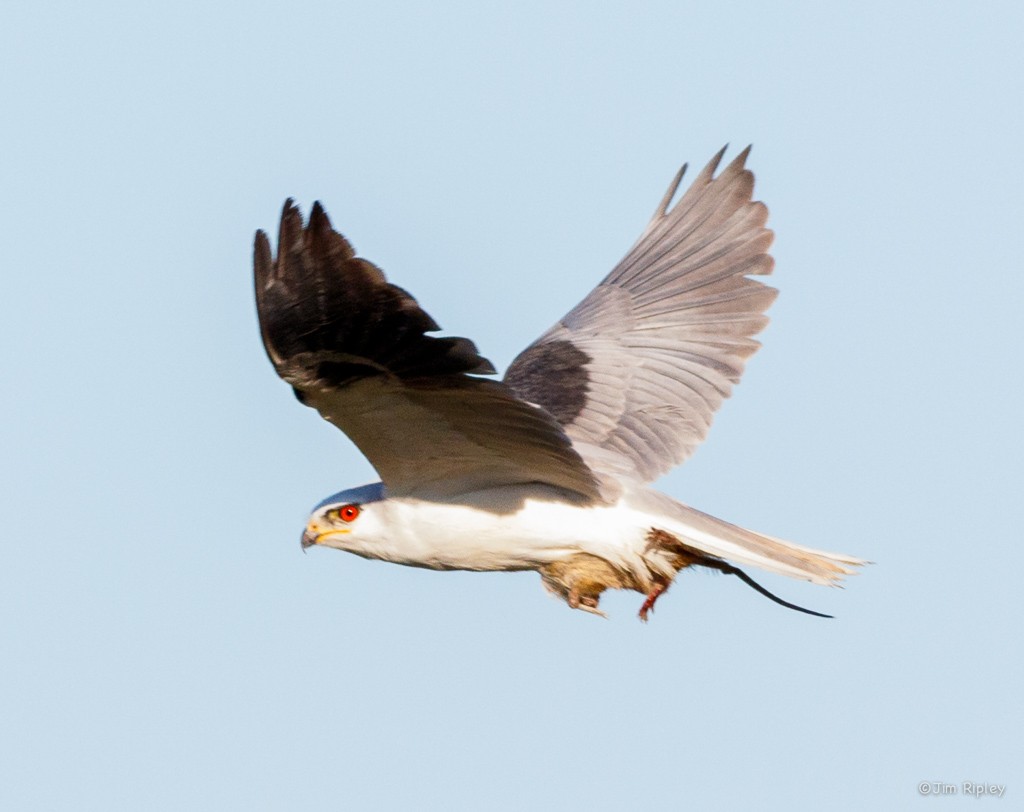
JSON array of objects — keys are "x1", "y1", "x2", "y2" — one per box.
[{"x1": 505, "y1": 147, "x2": 776, "y2": 481}]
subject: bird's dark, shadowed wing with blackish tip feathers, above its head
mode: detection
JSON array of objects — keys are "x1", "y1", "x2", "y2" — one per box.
[{"x1": 254, "y1": 201, "x2": 598, "y2": 498}]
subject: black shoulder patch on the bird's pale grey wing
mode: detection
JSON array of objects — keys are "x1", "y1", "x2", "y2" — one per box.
[{"x1": 505, "y1": 340, "x2": 590, "y2": 426}]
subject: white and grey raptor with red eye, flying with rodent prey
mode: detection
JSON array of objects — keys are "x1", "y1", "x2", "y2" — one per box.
[{"x1": 254, "y1": 147, "x2": 864, "y2": 621}]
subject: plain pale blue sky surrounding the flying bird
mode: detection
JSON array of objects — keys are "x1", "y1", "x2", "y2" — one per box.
[{"x1": 0, "y1": 2, "x2": 1024, "y2": 810}]
